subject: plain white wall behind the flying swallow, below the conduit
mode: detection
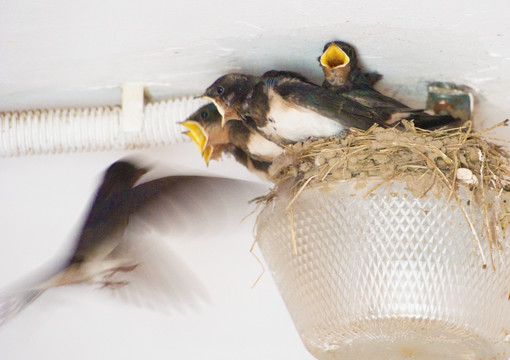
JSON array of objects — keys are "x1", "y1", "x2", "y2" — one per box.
[{"x1": 0, "y1": 144, "x2": 311, "y2": 360}]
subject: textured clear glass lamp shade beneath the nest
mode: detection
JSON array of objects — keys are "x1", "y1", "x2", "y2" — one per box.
[{"x1": 257, "y1": 182, "x2": 510, "y2": 360}]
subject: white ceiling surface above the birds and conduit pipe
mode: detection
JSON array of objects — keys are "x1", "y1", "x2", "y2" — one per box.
[{"x1": 0, "y1": 0, "x2": 510, "y2": 132}]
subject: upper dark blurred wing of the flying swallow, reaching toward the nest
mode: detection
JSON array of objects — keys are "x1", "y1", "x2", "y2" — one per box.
[{"x1": 126, "y1": 176, "x2": 268, "y2": 238}]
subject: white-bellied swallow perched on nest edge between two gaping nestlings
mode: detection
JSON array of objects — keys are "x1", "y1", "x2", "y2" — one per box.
[{"x1": 206, "y1": 70, "x2": 390, "y2": 145}]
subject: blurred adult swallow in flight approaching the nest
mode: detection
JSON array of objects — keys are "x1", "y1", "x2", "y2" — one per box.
[{"x1": 0, "y1": 161, "x2": 261, "y2": 324}]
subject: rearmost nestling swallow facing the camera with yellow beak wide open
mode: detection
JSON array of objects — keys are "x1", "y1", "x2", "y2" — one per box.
[{"x1": 318, "y1": 41, "x2": 459, "y2": 129}]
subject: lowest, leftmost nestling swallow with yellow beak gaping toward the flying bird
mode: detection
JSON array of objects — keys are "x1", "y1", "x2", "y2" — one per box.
[{"x1": 181, "y1": 103, "x2": 283, "y2": 166}]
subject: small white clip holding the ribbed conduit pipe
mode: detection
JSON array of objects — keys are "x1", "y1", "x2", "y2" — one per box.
[{"x1": 120, "y1": 83, "x2": 150, "y2": 132}]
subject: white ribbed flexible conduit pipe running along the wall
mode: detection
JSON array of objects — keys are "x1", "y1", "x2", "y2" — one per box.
[{"x1": 0, "y1": 97, "x2": 204, "y2": 157}]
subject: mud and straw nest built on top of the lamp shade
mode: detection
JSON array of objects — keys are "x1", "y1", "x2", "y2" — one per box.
[{"x1": 263, "y1": 120, "x2": 510, "y2": 268}]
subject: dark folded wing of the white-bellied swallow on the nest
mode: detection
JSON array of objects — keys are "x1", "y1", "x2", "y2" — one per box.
[{"x1": 268, "y1": 75, "x2": 381, "y2": 129}]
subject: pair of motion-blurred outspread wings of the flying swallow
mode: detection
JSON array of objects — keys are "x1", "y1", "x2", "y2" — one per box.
[{"x1": 102, "y1": 176, "x2": 267, "y2": 310}]
